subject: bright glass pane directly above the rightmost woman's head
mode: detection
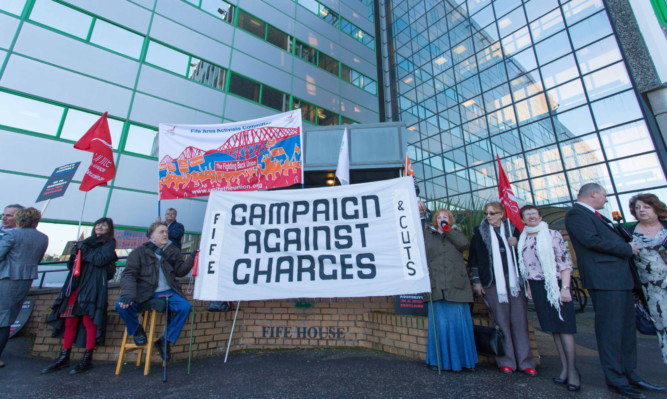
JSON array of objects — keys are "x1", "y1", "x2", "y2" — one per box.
[{"x1": 609, "y1": 153, "x2": 667, "y2": 192}]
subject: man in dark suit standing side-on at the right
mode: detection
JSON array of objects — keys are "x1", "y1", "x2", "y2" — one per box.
[{"x1": 565, "y1": 183, "x2": 665, "y2": 398}]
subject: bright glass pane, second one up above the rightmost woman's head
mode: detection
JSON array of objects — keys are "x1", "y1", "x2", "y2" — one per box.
[{"x1": 600, "y1": 121, "x2": 654, "y2": 159}]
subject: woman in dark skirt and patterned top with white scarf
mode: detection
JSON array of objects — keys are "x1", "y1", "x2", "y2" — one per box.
[{"x1": 518, "y1": 205, "x2": 581, "y2": 392}]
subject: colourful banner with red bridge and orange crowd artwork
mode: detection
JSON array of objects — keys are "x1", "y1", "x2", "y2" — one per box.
[{"x1": 159, "y1": 109, "x2": 303, "y2": 200}]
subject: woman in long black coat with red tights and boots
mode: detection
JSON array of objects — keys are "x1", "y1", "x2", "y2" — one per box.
[{"x1": 42, "y1": 218, "x2": 118, "y2": 374}]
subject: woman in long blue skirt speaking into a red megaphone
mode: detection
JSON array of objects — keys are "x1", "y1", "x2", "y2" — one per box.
[{"x1": 424, "y1": 209, "x2": 477, "y2": 371}]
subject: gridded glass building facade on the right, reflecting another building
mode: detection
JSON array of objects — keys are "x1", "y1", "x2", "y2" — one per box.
[{"x1": 387, "y1": 0, "x2": 667, "y2": 220}]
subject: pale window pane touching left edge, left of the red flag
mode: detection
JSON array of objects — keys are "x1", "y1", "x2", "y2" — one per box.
[{"x1": 0, "y1": 92, "x2": 63, "y2": 137}]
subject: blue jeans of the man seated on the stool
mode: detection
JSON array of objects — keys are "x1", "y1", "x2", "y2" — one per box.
[{"x1": 116, "y1": 290, "x2": 192, "y2": 343}]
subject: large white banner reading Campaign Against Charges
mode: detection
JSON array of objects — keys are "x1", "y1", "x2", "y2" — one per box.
[{"x1": 194, "y1": 177, "x2": 431, "y2": 301}]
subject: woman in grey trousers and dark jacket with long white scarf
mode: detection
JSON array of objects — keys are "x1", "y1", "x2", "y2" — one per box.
[{"x1": 468, "y1": 202, "x2": 537, "y2": 376}]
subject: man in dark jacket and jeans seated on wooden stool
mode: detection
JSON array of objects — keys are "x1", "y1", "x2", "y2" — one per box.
[{"x1": 116, "y1": 222, "x2": 194, "y2": 361}]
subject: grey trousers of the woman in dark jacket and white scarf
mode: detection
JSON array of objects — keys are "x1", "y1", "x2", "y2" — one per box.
[{"x1": 484, "y1": 284, "x2": 536, "y2": 370}]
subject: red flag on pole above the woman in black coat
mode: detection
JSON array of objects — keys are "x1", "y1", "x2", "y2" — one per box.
[{"x1": 74, "y1": 112, "x2": 116, "y2": 191}]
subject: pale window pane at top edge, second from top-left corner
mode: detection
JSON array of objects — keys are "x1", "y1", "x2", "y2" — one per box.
[{"x1": 30, "y1": 0, "x2": 93, "y2": 39}]
